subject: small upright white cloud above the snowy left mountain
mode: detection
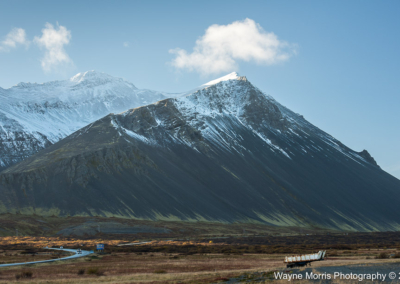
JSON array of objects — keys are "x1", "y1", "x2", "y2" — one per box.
[{"x1": 34, "y1": 23, "x2": 73, "y2": 72}]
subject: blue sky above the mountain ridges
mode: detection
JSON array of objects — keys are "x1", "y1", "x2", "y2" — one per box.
[{"x1": 0, "y1": 0, "x2": 400, "y2": 178}]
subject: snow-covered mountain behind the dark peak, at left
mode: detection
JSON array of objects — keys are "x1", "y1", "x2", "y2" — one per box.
[{"x1": 0, "y1": 71, "x2": 166, "y2": 170}]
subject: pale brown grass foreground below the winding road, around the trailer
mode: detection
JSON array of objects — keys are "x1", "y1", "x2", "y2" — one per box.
[{"x1": 0, "y1": 246, "x2": 399, "y2": 283}]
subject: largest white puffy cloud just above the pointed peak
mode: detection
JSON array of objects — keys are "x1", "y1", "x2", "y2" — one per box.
[{"x1": 169, "y1": 19, "x2": 296, "y2": 75}]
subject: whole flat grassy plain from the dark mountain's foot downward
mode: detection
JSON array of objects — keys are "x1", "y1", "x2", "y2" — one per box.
[{"x1": 0, "y1": 215, "x2": 400, "y2": 284}]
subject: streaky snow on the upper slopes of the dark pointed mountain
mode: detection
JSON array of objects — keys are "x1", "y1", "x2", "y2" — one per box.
[{"x1": 119, "y1": 72, "x2": 379, "y2": 167}]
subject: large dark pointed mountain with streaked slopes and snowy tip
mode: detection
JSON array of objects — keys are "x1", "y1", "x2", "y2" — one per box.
[{"x1": 0, "y1": 73, "x2": 400, "y2": 231}]
